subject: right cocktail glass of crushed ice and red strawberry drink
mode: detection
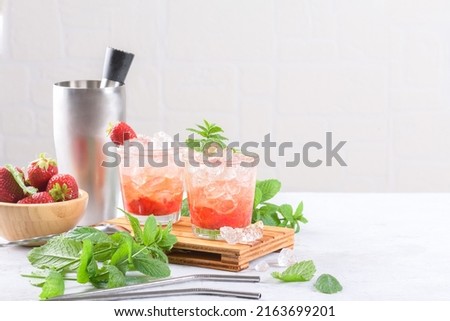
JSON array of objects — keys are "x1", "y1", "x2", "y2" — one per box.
[{"x1": 185, "y1": 153, "x2": 256, "y2": 239}]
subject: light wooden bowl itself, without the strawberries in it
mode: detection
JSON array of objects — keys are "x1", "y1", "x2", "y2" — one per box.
[{"x1": 0, "y1": 189, "x2": 89, "y2": 241}]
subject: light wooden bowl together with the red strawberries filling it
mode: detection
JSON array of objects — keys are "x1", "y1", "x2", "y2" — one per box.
[{"x1": 0, "y1": 153, "x2": 89, "y2": 241}]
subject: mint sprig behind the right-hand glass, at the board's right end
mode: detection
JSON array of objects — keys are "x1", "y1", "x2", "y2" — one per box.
[{"x1": 252, "y1": 179, "x2": 308, "y2": 233}]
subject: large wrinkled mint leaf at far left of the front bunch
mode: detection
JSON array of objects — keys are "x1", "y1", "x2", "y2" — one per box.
[{"x1": 28, "y1": 236, "x2": 82, "y2": 270}]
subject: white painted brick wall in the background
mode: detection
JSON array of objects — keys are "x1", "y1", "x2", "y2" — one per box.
[{"x1": 0, "y1": 0, "x2": 450, "y2": 192}]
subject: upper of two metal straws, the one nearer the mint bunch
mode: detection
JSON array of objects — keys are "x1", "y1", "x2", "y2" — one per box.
[{"x1": 51, "y1": 274, "x2": 260, "y2": 301}]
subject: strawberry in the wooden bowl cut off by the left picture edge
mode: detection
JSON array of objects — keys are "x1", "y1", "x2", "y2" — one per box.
[{"x1": 0, "y1": 165, "x2": 36, "y2": 203}]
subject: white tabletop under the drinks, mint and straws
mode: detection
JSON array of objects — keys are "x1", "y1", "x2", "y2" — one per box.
[{"x1": 0, "y1": 193, "x2": 450, "y2": 301}]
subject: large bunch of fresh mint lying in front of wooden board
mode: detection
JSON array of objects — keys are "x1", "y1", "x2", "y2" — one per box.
[{"x1": 23, "y1": 212, "x2": 177, "y2": 299}]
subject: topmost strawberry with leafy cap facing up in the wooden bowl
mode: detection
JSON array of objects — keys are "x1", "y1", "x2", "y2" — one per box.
[{"x1": 27, "y1": 153, "x2": 58, "y2": 191}]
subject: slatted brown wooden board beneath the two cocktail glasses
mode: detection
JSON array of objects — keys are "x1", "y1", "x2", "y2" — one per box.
[{"x1": 108, "y1": 217, "x2": 294, "y2": 272}]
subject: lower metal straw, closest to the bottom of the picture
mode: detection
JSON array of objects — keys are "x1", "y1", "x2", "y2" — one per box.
[{"x1": 53, "y1": 288, "x2": 261, "y2": 301}]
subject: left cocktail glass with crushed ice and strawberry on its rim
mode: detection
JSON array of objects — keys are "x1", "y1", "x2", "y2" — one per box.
[{"x1": 118, "y1": 144, "x2": 183, "y2": 224}]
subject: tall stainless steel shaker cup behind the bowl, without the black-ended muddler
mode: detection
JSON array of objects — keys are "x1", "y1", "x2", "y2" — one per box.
[{"x1": 53, "y1": 80, "x2": 126, "y2": 225}]
